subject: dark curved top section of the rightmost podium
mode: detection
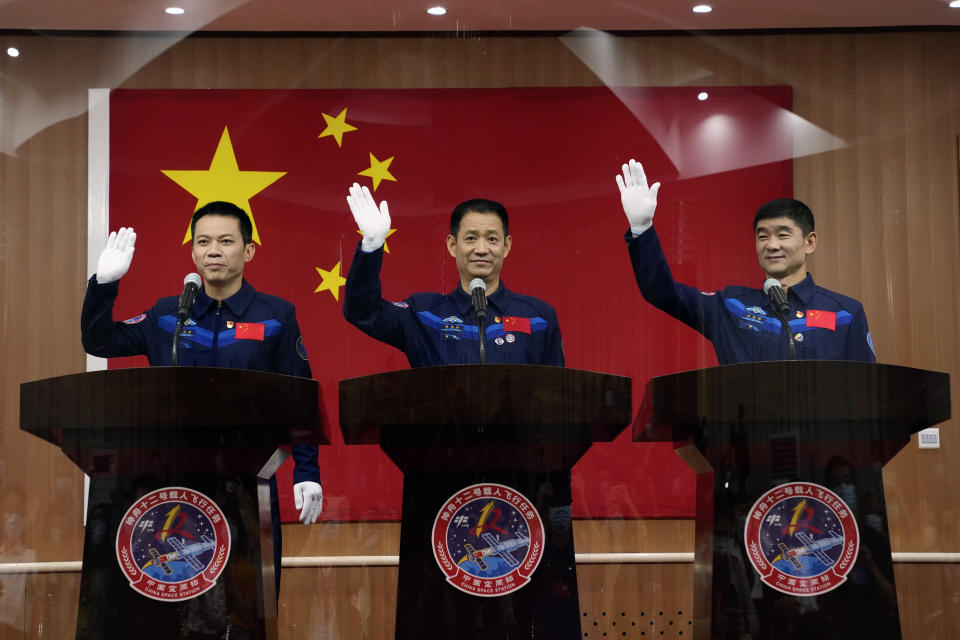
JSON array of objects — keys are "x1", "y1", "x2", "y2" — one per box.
[{"x1": 633, "y1": 360, "x2": 950, "y2": 441}]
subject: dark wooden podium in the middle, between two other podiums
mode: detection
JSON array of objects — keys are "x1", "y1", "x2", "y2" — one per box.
[{"x1": 340, "y1": 365, "x2": 631, "y2": 640}]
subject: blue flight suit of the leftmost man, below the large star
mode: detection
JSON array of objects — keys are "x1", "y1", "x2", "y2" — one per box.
[{"x1": 80, "y1": 275, "x2": 320, "y2": 593}]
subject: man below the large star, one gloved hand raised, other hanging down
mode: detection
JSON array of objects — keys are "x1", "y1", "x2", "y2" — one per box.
[{"x1": 80, "y1": 202, "x2": 323, "y2": 593}]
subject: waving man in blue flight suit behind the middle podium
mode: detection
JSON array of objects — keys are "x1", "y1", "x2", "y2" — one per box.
[{"x1": 343, "y1": 183, "x2": 564, "y2": 367}]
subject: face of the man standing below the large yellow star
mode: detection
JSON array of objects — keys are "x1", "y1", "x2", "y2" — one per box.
[{"x1": 193, "y1": 215, "x2": 254, "y2": 287}]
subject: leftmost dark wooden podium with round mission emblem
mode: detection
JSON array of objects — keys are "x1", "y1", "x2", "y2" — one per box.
[{"x1": 20, "y1": 367, "x2": 329, "y2": 640}]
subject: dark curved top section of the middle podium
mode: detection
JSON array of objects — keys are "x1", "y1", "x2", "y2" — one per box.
[{"x1": 340, "y1": 364, "x2": 632, "y2": 444}]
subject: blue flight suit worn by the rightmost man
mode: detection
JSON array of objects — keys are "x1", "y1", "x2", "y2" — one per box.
[{"x1": 625, "y1": 227, "x2": 877, "y2": 364}]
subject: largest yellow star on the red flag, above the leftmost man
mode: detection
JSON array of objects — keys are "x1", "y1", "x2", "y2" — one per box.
[{"x1": 163, "y1": 127, "x2": 287, "y2": 244}]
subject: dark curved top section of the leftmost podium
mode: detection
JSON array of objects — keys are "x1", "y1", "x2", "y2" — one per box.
[{"x1": 20, "y1": 367, "x2": 329, "y2": 443}]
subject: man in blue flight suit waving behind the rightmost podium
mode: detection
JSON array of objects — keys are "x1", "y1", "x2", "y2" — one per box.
[{"x1": 617, "y1": 160, "x2": 876, "y2": 364}]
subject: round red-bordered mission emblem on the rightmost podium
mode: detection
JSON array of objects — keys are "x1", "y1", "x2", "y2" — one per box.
[{"x1": 743, "y1": 482, "x2": 860, "y2": 596}]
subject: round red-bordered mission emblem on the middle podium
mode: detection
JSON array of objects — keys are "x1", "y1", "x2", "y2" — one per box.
[{"x1": 433, "y1": 483, "x2": 544, "y2": 597}]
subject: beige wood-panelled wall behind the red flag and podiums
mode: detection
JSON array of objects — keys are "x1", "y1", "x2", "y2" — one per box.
[{"x1": 0, "y1": 32, "x2": 960, "y2": 638}]
